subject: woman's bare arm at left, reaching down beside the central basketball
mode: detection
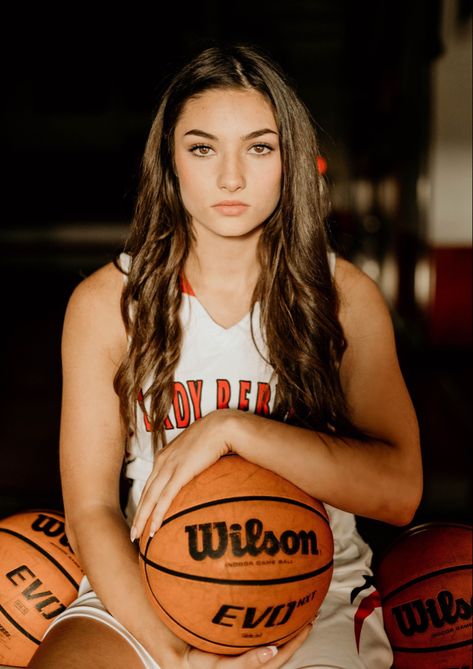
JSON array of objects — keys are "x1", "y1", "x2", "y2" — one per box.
[{"x1": 60, "y1": 266, "x2": 185, "y2": 656}]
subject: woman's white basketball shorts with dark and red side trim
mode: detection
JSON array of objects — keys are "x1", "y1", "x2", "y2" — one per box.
[{"x1": 46, "y1": 574, "x2": 393, "y2": 669}]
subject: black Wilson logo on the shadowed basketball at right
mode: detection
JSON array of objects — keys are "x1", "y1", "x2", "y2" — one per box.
[{"x1": 391, "y1": 590, "x2": 472, "y2": 636}]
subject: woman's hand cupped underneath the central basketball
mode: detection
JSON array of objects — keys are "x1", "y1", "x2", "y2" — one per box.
[{"x1": 163, "y1": 624, "x2": 312, "y2": 669}]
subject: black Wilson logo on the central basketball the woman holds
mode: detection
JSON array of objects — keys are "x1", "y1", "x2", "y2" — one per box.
[{"x1": 184, "y1": 518, "x2": 319, "y2": 561}]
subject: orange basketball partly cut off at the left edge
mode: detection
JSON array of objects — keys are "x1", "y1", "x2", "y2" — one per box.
[{"x1": 0, "y1": 511, "x2": 83, "y2": 667}]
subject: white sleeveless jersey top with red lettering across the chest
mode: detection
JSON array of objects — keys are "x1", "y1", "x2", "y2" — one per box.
[{"x1": 120, "y1": 254, "x2": 371, "y2": 579}]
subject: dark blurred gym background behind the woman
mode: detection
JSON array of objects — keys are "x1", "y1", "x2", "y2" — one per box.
[{"x1": 0, "y1": 0, "x2": 472, "y2": 549}]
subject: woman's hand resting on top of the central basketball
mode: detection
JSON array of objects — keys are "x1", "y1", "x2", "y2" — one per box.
[{"x1": 130, "y1": 409, "x2": 240, "y2": 541}]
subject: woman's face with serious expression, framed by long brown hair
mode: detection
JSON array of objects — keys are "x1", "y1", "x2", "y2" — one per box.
[{"x1": 174, "y1": 89, "x2": 281, "y2": 237}]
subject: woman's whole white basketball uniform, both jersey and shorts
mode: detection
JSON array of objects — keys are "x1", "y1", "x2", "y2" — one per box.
[{"x1": 42, "y1": 254, "x2": 393, "y2": 669}]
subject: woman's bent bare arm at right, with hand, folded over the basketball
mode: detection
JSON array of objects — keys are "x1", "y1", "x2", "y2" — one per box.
[{"x1": 134, "y1": 260, "x2": 422, "y2": 535}]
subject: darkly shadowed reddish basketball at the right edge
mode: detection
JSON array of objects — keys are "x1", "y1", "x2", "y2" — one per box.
[{"x1": 377, "y1": 523, "x2": 472, "y2": 669}]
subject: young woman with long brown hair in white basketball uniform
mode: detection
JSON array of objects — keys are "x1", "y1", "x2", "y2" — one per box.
[{"x1": 30, "y1": 47, "x2": 421, "y2": 669}]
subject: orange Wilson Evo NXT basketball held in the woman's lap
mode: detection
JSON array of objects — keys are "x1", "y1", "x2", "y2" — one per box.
[{"x1": 140, "y1": 455, "x2": 333, "y2": 654}]
